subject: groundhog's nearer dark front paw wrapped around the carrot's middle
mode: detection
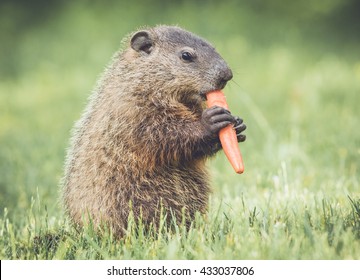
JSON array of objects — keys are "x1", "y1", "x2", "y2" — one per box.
[{"x1": 201, "y1": 106, "x2": 236, "y2": 138}]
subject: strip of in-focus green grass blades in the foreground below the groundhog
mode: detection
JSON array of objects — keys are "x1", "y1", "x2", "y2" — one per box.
[{"x1": 1, "y1": 194, "x2": 360, "y2": 259}]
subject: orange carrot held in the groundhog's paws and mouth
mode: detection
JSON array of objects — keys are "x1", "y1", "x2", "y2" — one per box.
[{"x1": 206, "y1": 90, "x2": 244, "y2": 174}]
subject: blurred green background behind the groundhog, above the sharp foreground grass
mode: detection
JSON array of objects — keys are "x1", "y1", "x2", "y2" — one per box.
[{"x1": 0, "y1": 0, "x2": 360, "y2": 223}]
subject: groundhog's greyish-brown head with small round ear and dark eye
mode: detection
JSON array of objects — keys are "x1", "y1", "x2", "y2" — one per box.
[{"x1": 123, "y1": 26, "x2": 232, "y2": 104}]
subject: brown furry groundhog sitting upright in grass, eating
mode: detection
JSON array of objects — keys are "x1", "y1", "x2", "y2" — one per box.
[{"x1": 63, "y1": 26, "x2": 246, "y2": 236}]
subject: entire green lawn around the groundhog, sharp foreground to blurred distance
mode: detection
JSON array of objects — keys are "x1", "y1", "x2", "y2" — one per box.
[{"x1": 0, "y1": 1, "x2": 360, "y2": 259}]
